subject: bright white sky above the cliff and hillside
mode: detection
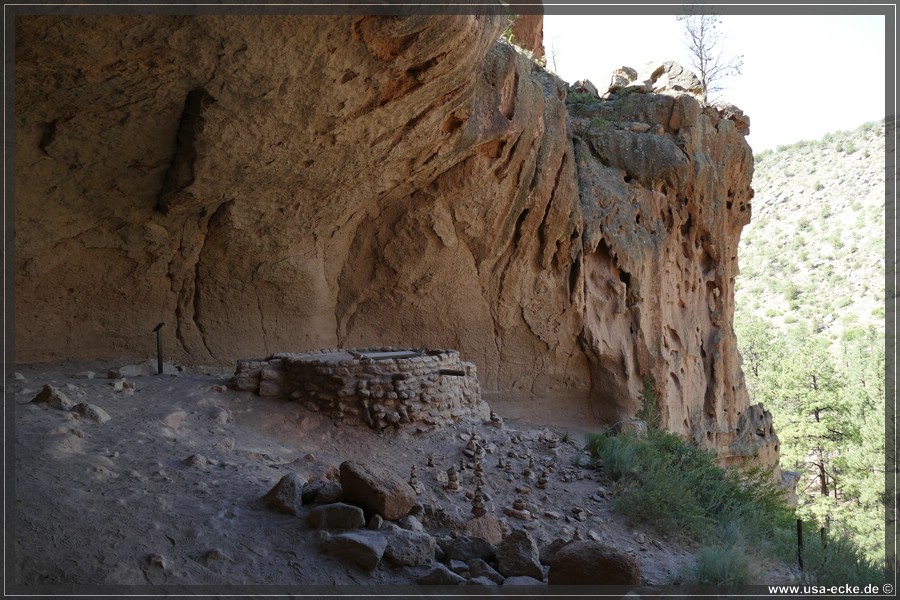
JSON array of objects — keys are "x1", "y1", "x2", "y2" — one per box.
[{"x1": 544, "y1": 15, "x2": 885, "y2": 152}]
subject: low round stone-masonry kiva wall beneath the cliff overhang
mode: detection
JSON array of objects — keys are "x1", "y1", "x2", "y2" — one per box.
[{"x1": 235, "y1": 348, "x2": 490, "y2": 430}]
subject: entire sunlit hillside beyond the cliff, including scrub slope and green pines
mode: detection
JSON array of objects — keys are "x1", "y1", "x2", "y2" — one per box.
[{"x1": 735, "y1": 121, "x2": 885, "y2": 562}]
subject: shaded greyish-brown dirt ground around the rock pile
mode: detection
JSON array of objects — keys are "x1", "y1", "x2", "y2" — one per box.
[{"x1": 6, "y1": 362, "x2": 792, "y2": 592}]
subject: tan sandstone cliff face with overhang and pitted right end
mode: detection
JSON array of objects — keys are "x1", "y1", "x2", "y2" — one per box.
[{"x1": 15, "y1": 16, "x2": 777, "y2": 461}]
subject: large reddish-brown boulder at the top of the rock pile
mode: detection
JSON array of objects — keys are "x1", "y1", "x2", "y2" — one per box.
[{"x1": 341, "y1": 461, "x2": 416, "y2": 521}]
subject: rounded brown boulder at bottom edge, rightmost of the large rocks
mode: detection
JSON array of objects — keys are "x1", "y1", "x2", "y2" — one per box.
[{"x1": 547, "y1": 540, "x2": 641, "y2": 585}]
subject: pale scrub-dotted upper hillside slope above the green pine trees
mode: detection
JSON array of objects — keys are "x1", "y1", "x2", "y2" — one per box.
[{"x1": 735, "y1": 123, "x2": 885, "y2": 338}]
